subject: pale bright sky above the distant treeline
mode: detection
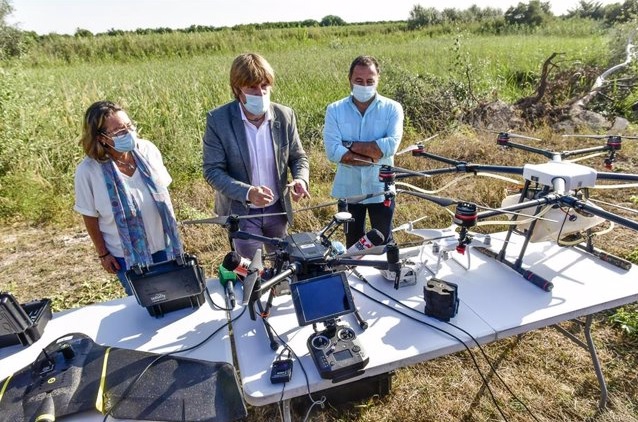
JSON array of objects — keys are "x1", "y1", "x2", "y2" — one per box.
[{"x1": 7, "y1": 0, "x2": 622, "y2": 35}]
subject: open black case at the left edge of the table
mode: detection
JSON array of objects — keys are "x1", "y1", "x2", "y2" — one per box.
[{"x1": 0, "y1": 293, "x2": 52, "y2": 348}]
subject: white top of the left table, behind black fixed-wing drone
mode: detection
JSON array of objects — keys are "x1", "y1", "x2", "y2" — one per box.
[{"x1": 0, "y1": 279, "x2": 233, "y2": 421}]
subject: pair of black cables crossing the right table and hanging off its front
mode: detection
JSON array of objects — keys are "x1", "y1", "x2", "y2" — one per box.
[{"x1": 352, "y1": 270, "x2": 538, "y2": 421}]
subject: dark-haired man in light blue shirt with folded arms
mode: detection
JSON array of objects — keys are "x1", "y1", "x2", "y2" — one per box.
[{"x1": 323, "y1": 56, "x2": 403, "y2": 247}]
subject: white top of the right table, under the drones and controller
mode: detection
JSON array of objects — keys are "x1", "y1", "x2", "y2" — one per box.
[{"x1": 233, "y1": 234, "x2": 638, "y2": 406}]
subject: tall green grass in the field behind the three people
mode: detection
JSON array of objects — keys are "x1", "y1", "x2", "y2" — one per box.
[{"x1": 0, "y1": 25, "x2": 607, "y2": 222}]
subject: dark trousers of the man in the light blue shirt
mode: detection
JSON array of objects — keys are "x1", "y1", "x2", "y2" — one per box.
[{"x1": 345, "y1": 199, "x2": 395, "y2": 248}]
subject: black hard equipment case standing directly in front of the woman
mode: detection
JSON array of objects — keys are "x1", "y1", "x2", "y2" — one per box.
[{"x1": 126, "y1": 254, "x2": 206, "y2": 318}]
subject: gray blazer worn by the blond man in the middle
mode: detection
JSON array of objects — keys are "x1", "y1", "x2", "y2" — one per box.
[{"x1": 203, "y1": 100, "x2": 309, "y2": 223}]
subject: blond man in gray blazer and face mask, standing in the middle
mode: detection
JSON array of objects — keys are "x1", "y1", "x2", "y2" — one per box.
[{"x1": 203, "y1": 53, "x2": 310, "y2": 259}]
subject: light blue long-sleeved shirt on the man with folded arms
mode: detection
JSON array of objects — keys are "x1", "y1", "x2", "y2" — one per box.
[{"x1": 323, "y1": 93, "x2": 403, "y2": 204}]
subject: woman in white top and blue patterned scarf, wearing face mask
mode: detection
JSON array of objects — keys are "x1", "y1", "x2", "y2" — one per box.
[{"x1": 74, "y1": 101, "x2": 182, "y2": 295}]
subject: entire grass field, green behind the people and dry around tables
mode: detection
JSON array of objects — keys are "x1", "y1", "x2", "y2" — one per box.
[{"x1": 0, "y1": 20, "x2": 638, "y2": 421}]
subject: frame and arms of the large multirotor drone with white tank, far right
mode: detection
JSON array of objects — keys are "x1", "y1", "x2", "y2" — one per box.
[{"x1": 379, "y1": 132, "x2": 638, "y2": 291}]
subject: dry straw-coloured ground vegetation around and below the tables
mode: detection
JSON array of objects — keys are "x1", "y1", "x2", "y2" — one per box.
[{"x1": 0, "y1": 132, "x2": 638, "y2": 421}]
